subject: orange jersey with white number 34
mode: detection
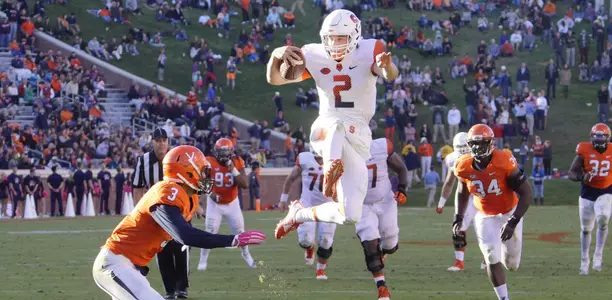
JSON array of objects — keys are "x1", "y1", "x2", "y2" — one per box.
[{"x1": 455, "y1": 150, "x2": 518, "y2": 215}]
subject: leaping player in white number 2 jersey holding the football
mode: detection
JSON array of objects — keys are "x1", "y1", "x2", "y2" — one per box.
[{"x1": 267, "y1": 9, "x2": 398, "y2": 239}]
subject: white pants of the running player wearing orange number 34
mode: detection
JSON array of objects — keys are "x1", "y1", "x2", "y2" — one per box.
[{"x1": 474, "y1": 208, "x2": 523, "y2": 271}]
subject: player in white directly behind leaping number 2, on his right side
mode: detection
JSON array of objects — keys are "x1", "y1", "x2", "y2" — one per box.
[{"x1": 356, "y1": 138, "x2": 408, "y2": 300}]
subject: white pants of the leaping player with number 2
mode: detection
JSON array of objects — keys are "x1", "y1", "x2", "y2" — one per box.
[{"x1": 310, "y1": 116, "x2": 372, "y2": 223}]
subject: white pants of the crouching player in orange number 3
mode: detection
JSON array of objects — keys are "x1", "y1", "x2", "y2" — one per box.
[{"x1": 92, "y1": 248, "x2": 164, "y2": 300}]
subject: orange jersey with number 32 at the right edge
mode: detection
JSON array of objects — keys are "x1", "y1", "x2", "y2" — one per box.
[{"x1": 576, "y1": 142, "x2": 612, "y2": 189}]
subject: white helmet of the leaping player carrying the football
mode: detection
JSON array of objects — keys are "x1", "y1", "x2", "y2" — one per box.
[{"x1": 319, "y1": 9, "x2": 361, "y2": 59}]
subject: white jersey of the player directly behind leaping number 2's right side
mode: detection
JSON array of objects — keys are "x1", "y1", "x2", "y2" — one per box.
[{"x1": 364, "y1": 138, "x2": 393, "y2": 204}]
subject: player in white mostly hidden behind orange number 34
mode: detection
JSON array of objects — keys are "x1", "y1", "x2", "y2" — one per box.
[{"x1": 436, "y1": 132, "x2": 486, "y2": 272}]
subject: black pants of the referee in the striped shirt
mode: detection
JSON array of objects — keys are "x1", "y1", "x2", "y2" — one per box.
[{"x1": 157, "y1": 240, "x2": 189, "y2": 294}]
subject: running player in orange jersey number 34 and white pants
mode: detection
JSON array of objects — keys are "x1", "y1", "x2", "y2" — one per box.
[{"x1": 453, "y1": 124, "x2": 532, "y2": 300}]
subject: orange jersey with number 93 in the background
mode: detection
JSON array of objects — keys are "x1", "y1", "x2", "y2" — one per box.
[{"x1": 206, "y1": 156, "x2": 244, "y2": 204}]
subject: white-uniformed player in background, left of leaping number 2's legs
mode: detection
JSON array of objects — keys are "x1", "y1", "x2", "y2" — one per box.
[{"x1": 279, "y1": 150, "x2": 336, "y2": 280}]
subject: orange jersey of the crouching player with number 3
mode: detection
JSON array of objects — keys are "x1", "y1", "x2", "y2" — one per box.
[{"x1": 104, "y1": 180, "x2": 198, "y2": 266}]
